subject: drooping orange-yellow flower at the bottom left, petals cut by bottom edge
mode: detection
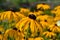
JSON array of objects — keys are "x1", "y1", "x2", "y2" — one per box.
[{"x1": 3, "y1": 29, "x2": 24, "y2": 40}]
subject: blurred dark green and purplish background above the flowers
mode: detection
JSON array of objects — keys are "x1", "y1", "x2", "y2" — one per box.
[{"x1": 0, "y1": 0, "x2": 60, "y2": 10}]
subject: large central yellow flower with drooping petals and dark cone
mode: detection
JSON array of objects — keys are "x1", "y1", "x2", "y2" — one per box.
[{"x1": 16, "y1": 14, "x2": 42, "y2": 35}]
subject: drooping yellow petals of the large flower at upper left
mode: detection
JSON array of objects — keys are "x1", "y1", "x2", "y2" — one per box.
[{"x1": 0, "y1": 11, "x2": 25, "y2": 21}]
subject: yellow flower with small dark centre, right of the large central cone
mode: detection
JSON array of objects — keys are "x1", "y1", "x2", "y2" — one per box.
[{"x1": 36, "y1": 15, "x2": 53, "y2": 28}]
